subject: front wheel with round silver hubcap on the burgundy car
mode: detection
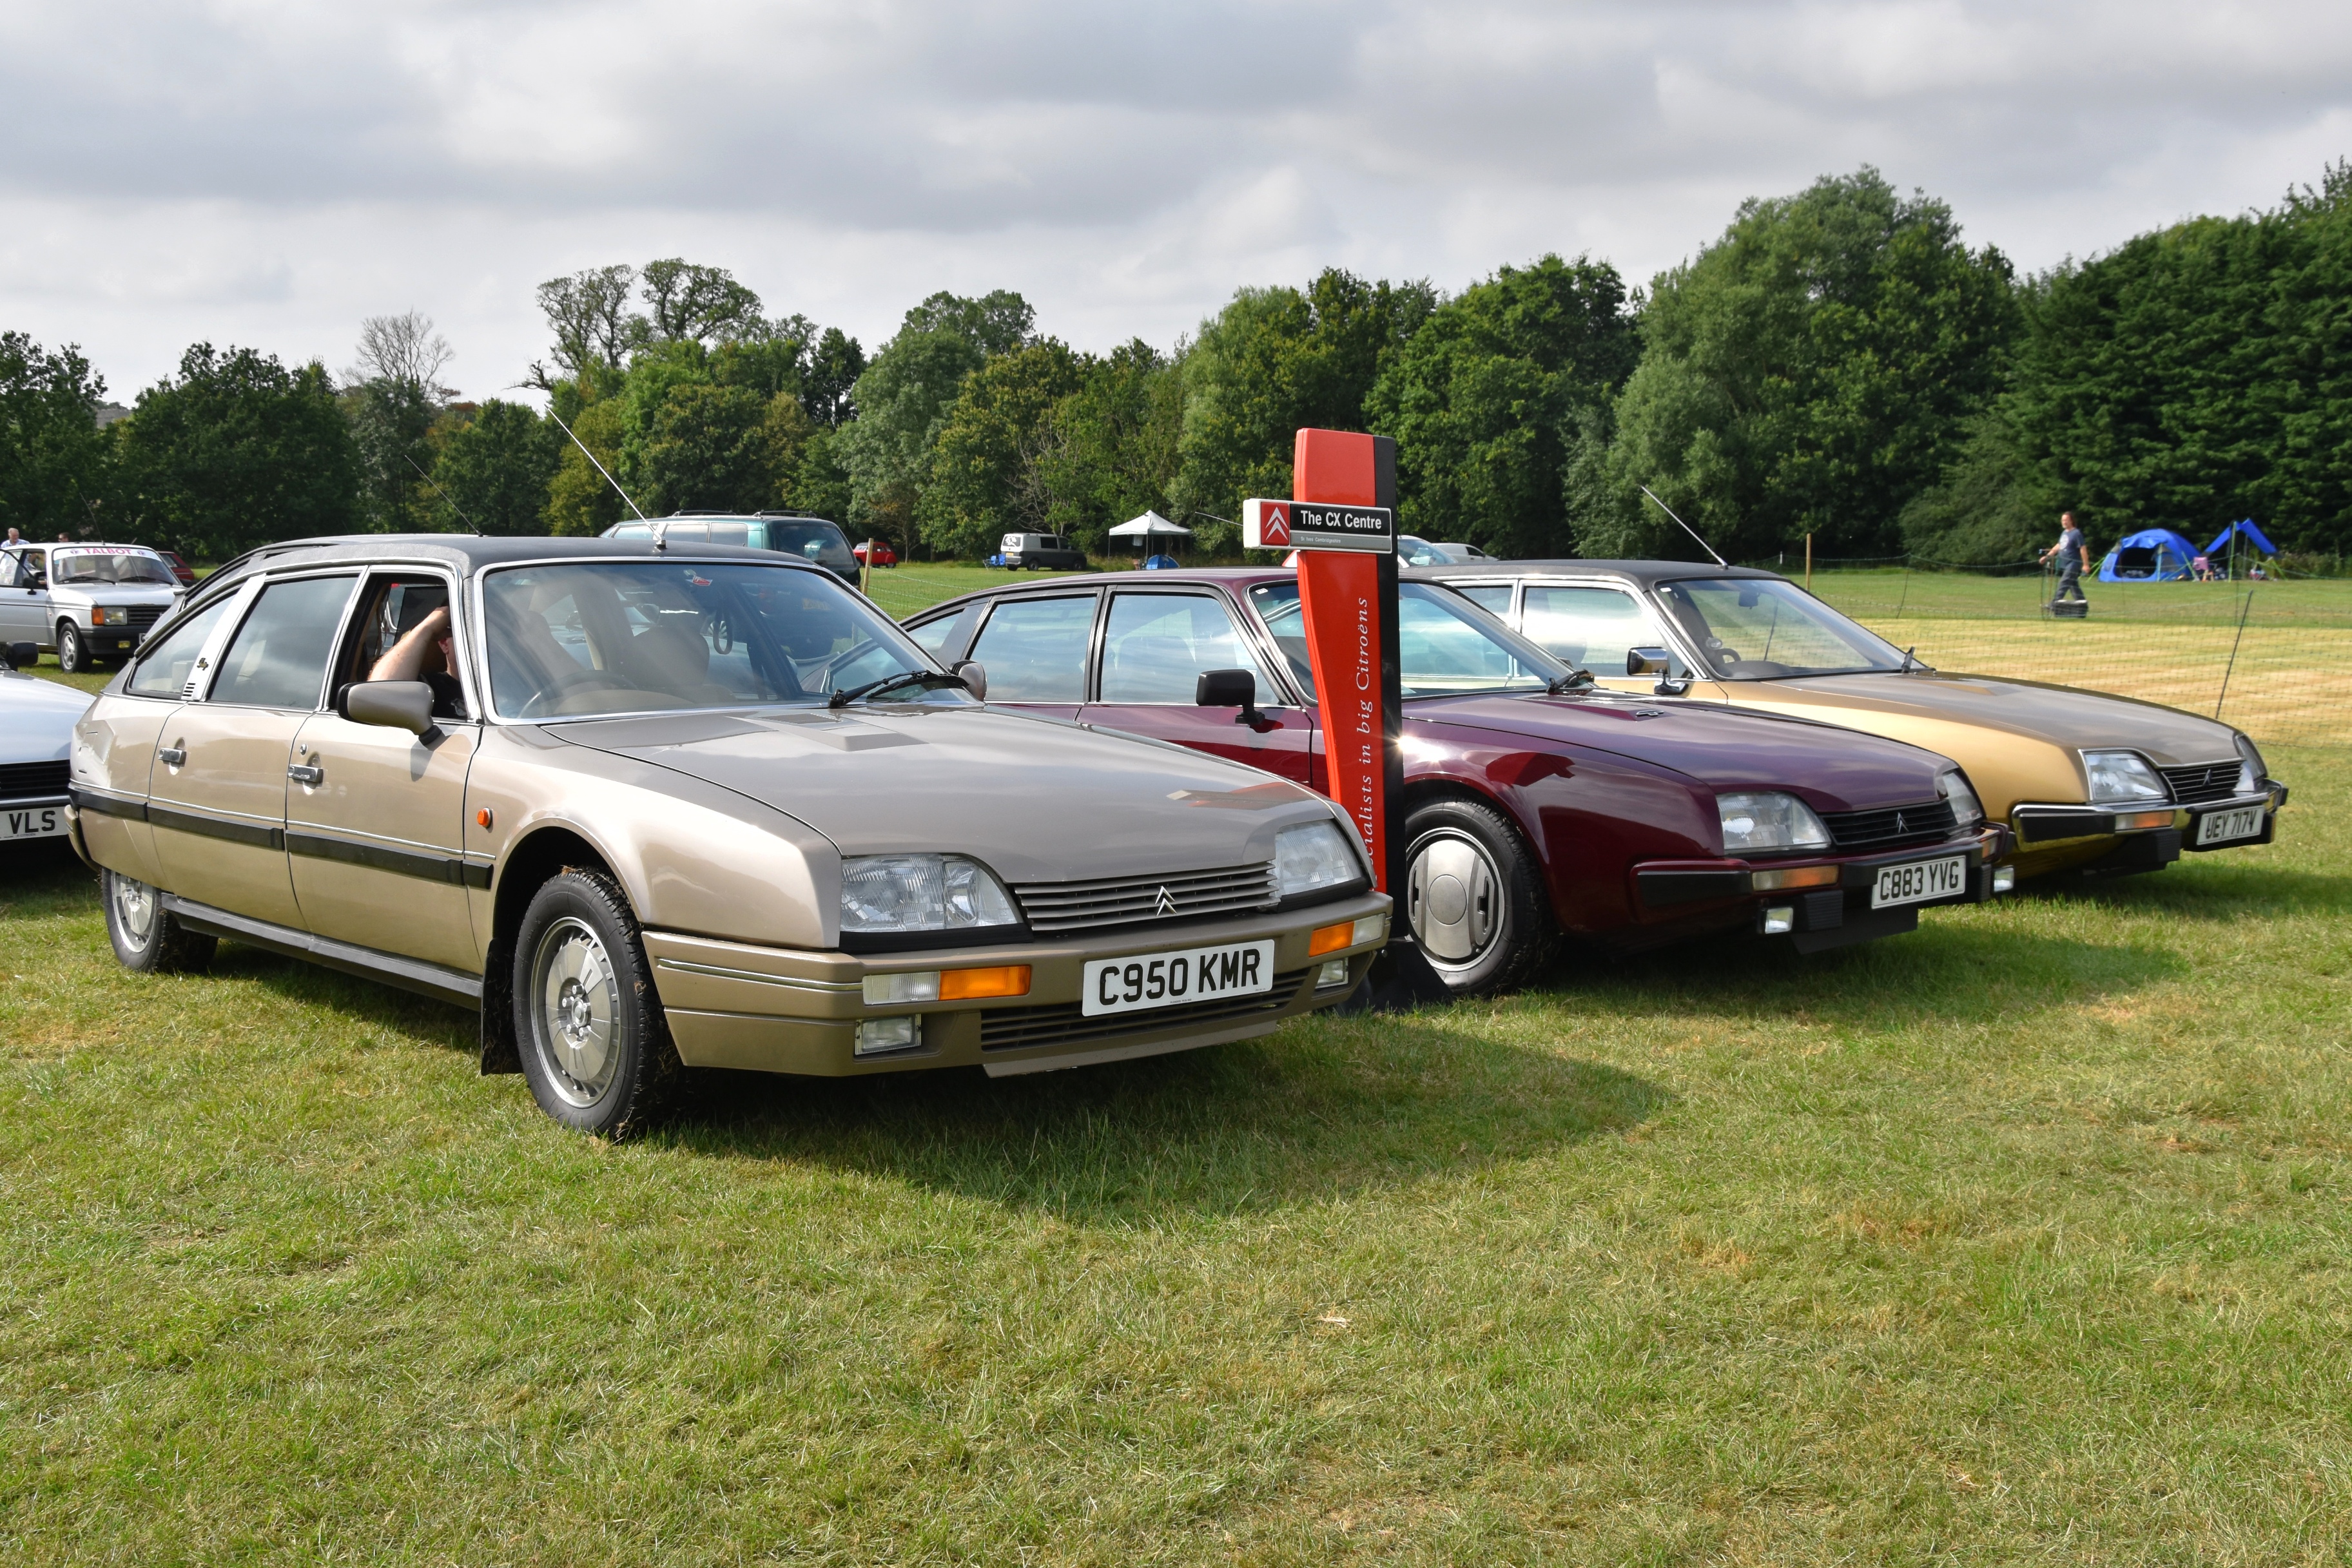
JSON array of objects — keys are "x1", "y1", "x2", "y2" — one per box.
[{"x1": 1404, "y1": 797, "x2": 1559, "y2": 997}]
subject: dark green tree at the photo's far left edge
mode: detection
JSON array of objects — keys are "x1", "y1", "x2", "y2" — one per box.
[{"x1": 0, "y1": 331, "x2": 108, "y2": 538}]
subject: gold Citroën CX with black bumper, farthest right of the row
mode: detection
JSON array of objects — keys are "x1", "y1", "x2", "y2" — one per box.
[{"x1": 1406, "y1": 559, "x2": 2286, "y2": 879}]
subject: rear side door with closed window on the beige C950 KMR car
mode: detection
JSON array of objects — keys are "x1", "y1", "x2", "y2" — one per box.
[{"x1": 148, "y1": 571, "x2": 358, "y2": 929}]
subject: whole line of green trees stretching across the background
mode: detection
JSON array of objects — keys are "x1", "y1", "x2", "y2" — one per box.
[{"x1": 0, "y1": 162, "x2": 2352, "y2": 564}]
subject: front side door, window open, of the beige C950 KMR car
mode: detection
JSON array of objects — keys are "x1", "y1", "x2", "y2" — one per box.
[{"x1": 287, "y1": 571, "x2": 489, "y2": 973}]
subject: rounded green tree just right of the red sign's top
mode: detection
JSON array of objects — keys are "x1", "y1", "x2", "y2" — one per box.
[{"x1": 1366, "y1": 256, "x2": 1639, "y2": 557}]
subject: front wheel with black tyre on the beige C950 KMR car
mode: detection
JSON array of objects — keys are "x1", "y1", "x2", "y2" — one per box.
[{"x1": 512, "y1": 870, "x2": 685, "y2": 1137}]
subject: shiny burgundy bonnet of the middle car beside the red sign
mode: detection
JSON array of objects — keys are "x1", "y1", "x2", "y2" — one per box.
[{"x1": 1406, "y1": 693, "x2": 1952, "y2": 811}]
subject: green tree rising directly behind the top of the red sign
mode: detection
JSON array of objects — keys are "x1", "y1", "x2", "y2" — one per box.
[{"x1": 1171, "y1": 268, "x2": 1437, "y2": 548}]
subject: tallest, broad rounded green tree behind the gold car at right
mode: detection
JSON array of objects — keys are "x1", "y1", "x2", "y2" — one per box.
[{"x1": 1599, "y1": 167, "x2": 2020, "y2": 559}]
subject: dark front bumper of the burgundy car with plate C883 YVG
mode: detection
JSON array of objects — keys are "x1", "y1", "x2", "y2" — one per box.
[{"x1": 1632, "y1": 823, "x2": 2016, "y2": 952}]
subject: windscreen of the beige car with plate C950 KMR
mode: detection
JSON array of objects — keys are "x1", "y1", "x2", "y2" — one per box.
[{"x1": 482, "y1": 562, "x2": 950, "y2": 719}]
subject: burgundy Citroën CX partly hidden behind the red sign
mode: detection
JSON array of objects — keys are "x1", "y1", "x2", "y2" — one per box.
[{"x1": 908, "y1": 566, "x2": 2011, "y2": 992}]
